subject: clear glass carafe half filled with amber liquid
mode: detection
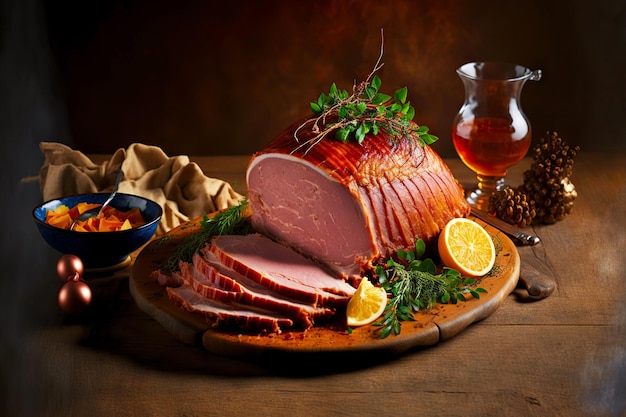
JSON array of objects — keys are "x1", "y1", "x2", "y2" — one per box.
[{"x1": 452, "y1": 62, "x2": 541, "y2": 210}]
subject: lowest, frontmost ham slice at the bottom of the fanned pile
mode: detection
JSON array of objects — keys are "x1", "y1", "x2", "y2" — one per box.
[{"x1": 166, "y1": 283, "x2": 293, "y2": 333}]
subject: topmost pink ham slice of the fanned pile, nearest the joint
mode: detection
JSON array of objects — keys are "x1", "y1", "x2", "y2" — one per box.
[{"x1": 203, "y1": 234, "x2": 355, "y2": 306}]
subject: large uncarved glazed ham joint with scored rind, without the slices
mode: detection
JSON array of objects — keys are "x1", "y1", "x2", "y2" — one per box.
[{"x1": 246, "y1": 118, "x2": 470, "y2": 278}]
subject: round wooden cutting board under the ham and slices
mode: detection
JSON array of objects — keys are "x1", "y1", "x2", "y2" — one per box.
[{"x1": 130, "y1": 214, "x2": 520, "y2": 356}]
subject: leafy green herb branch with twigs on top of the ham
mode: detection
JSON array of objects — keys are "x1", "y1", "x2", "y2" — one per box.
[{"x1": 294, "y1": 32, "x2": 437, "y2": 150}]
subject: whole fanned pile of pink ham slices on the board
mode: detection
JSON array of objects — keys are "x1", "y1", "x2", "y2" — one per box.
[{"x1": 152, "y1": 234, "x2": 348, "y2": 333}]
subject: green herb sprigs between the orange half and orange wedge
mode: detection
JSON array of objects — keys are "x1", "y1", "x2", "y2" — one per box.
[{"x1": 374, "y1": 239, "x2": 487, "y2": 339}]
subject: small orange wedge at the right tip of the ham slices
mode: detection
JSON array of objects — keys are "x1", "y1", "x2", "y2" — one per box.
[{"x1": 346, "y1": 278, "x2": 387, "y2": 327}]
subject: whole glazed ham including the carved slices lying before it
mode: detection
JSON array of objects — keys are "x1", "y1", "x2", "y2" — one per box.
[{"x1": 153, "y1": 118, "x2": 470, "y2": 332}]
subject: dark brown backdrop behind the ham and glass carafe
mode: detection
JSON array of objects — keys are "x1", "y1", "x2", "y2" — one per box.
[{"x1": 45, "y1": 0, "x2": 626, "y2": 156}]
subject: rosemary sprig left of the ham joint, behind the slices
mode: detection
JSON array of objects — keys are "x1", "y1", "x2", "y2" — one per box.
[{"x1": 162, "y1": 200, "x2": 252, "y2": 272}]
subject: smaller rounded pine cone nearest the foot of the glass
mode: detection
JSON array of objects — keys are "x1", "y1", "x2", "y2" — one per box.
[{"x1": 489, "y1": 186, "x2": 536, "y2": 227}]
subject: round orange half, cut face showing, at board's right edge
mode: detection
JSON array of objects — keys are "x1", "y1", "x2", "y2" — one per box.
[{"x1": 438, "y1": 218, "x2": 496, "y2": 277}]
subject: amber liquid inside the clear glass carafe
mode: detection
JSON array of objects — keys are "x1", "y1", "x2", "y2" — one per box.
[{"x1": 452, "y1": 117, "x2": 531, "y2": 177}]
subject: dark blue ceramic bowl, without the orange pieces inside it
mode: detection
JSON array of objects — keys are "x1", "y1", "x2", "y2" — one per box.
[{"x1": 33, "y1": 193, "x2": 163, "y2": 269}]
